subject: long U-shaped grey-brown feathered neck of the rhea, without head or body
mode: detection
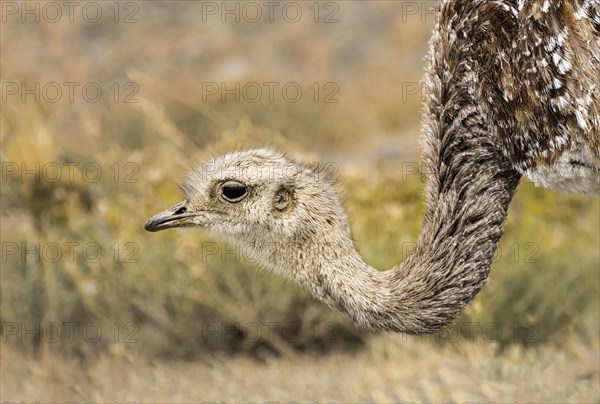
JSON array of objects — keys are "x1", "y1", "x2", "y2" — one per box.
[{"x1": 284, "y1": 1, "x2": 519, "y2": 334}]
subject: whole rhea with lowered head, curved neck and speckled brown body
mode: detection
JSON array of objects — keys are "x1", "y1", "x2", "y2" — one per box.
[{"x1": 146, "y1": 0, "x2": 600, "y2": 334}]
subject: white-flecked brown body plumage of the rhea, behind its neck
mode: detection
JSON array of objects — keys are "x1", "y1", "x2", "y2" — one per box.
[{"x1": 466, "y1": 0, "x2": 600, "y2": 194}]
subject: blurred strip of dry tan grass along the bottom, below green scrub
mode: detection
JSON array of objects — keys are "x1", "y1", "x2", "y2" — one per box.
[{"x1": 1, "y1": 336, "x2": 600, "y2": 403}]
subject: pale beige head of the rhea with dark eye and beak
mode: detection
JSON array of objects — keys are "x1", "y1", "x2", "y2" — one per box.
[{"x1": 145, "y1": 149, "x2": 349, "y2": 269}]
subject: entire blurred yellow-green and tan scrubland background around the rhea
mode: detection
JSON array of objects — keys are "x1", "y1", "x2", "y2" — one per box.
[{"x1": 0, "y1": 1, "x2": 600, "y2": 402}]
